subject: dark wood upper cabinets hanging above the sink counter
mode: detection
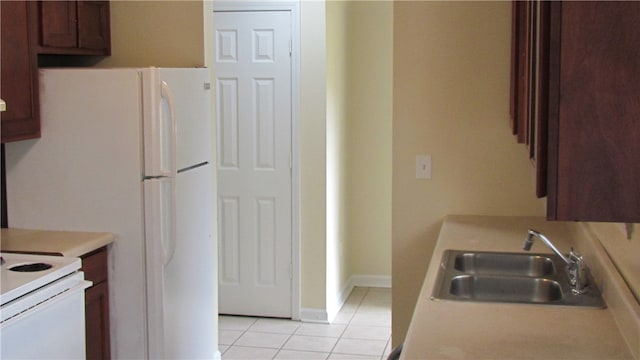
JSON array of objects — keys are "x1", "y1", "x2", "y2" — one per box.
[{"x1": 511, "y1": 1, "x2": 640, "y2": 222}]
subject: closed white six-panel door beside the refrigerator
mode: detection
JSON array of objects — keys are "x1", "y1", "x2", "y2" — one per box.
[{"x1": 214, "y1": 11, "x2": 291, "y2": 318}]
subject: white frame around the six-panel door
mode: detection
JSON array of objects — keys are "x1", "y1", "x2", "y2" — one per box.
[{"x1": 213, "y1": 1, "x2": 301, "y2": 320}]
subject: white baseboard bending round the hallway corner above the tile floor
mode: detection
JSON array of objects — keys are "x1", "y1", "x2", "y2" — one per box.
[{"x1": 300, "y1": 275, "x2": 391, "y2": 324}]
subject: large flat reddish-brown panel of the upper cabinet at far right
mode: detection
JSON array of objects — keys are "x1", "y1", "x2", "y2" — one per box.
[{"x1": 547, "y1": 1, "x2": 640, "y2": 222}]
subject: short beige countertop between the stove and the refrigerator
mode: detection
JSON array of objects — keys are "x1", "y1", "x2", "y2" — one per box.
[{"x1": 0, "y1": 228, "x2": 113, "y2": 257}]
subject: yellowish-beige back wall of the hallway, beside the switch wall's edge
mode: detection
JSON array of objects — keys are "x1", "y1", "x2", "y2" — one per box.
[{"x1": 347, "y1": 1, "x2": 393, "y2": 278}]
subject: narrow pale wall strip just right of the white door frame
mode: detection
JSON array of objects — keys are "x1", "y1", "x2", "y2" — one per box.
[{"x1": 300, "y1": 1, "x2": 327, "y2": 310}]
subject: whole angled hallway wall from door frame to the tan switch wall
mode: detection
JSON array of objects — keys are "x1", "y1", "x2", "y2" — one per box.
[{"x1": 300, "y1": 1, "x2": 393, "y2": 316}]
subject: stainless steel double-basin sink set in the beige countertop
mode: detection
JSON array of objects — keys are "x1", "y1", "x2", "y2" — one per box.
[{"x1": 431, "y1": 250, "x2": 606, "y2": 308}]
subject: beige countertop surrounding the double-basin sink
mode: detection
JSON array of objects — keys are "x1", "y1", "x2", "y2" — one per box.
[{"x1": 401, "y1": 216, "x2": 638, "y2": 359}]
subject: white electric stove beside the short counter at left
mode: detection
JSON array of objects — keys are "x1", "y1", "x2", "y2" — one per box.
[{"x1": 0, "y1": 253, "x2": 91, "y2": 359}]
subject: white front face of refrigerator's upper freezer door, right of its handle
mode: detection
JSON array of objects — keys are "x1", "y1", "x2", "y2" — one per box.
[{"x1": 157, "y1": 68, "x2": 213, "y2": 170}]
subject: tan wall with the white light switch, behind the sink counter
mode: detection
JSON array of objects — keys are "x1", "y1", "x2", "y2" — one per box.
[{"x1": 392, "y1": 1, "x2": 544, "y2": 345}]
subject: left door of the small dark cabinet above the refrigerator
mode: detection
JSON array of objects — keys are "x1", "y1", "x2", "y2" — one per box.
[{"x1": 39, "y1": 1, "x2": 78, "y2": 48}]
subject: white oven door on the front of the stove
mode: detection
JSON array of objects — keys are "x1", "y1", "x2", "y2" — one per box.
[{"x1": 0, "y1": 272, "x2": 91, "y2": 359}]
